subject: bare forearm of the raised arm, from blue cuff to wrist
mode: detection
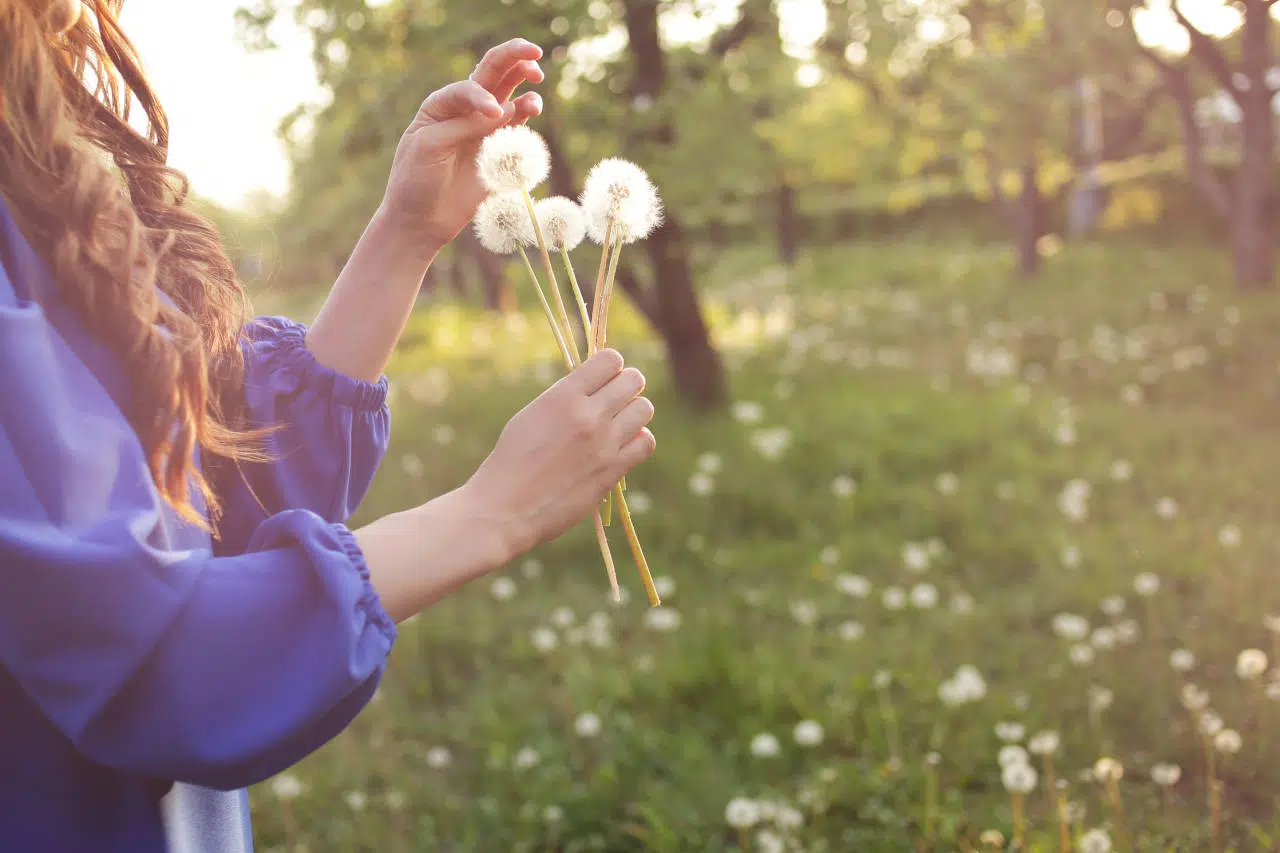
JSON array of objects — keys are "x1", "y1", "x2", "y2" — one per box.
[{"x1": 307, "y1": 204, "x2": 440, "y2": 382}]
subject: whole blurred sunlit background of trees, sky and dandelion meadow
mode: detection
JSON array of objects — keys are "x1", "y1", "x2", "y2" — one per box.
[{"x1": 124, "y1": 0, "x2": 1280, "y2": 853}]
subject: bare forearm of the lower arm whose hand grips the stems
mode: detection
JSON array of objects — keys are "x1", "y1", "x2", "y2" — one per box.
[{"x1": 355, "y1": 487, "x2": 522, "y2": 622}]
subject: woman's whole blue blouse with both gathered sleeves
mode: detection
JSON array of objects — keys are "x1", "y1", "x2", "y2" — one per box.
[{"x1": 0, "y1": 204, "x2": 396, "y2": 853}]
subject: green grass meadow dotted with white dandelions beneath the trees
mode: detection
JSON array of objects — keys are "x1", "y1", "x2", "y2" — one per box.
[{"x1": 244, "y1": 236, "x2": 1280, "y2": 853}]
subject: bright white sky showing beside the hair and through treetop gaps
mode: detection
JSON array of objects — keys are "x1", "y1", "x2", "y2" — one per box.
[{"x1": 122, "y1": 0, "x2": 1239, "y2": 206}]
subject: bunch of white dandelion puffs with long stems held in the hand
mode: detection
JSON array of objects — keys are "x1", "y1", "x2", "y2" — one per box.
[{"x1": 475, "y1": 126, "x2": 662, "y2": 607}]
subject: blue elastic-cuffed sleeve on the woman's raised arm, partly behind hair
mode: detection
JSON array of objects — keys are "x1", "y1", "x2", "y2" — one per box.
[{"x1": 219, "y1": 316, "x2": 390, "y2": 552}]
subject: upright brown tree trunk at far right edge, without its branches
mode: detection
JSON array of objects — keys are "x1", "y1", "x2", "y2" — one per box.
[{"x1": 1231, "y1": 2, "x2": 1275, "y2": 289}]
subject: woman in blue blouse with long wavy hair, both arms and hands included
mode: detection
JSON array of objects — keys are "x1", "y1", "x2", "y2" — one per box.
[{"x1": 0, "y1": 0, "x2": 654, "y2": 853}]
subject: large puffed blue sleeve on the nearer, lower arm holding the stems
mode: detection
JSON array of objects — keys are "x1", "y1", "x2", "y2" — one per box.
[{"x1": 0, "y1": 270, "x2": 396, "y2": 790}]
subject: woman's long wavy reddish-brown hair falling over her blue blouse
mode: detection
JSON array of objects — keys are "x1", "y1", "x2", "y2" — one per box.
[{"x1": 0, "y1": 0, "x2": 266, "y2": 530}]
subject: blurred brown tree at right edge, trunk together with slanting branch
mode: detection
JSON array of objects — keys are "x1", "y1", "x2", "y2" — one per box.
[{"x1": 1110, "y1": 0, "x2": 1280, "y2": 288}]
